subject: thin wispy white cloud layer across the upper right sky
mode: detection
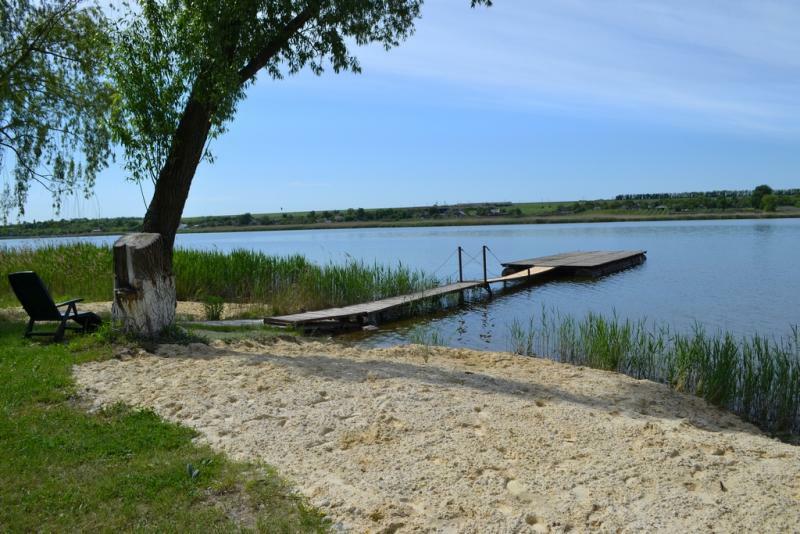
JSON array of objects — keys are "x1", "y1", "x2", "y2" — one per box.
[{"x1": 352, "y1": 0, "x2": 800, "y2": 135}]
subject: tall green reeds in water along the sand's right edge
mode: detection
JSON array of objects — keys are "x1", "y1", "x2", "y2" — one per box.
[{"x1": 510, "y1": 311, "x2": 800, "y2": 435}]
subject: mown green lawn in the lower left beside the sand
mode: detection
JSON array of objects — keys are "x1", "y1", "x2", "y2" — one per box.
[{"x1": 0, "y1": 321, "x2": 327, "y2": 532}]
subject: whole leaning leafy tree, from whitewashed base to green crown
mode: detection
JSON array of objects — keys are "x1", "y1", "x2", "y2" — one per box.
[{"x1": 110, "y1": 0, "x2": 491, "y2": 334}]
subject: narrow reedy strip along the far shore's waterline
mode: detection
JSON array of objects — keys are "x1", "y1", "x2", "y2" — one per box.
[{"x1": 0, "y1": 210, "x2": 800, "y2": 241}]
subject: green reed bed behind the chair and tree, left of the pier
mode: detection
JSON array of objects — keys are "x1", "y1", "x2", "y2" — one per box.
[{"x1": 0, "y1": 243, "x2": 436, "y2": 313}]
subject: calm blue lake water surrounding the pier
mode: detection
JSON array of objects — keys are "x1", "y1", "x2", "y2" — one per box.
[{"x1": 0, "y1": 219, "x2": 800, "y2": 349}]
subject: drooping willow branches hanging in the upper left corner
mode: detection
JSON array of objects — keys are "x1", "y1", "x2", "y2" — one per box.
[{"x1": 0, "y1": 0, "x2": 111, "y2": 220}]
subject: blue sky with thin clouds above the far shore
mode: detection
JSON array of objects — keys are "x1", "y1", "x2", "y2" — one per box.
[{"x1": 10, "y1": 0, "x2": 800, "y2": 220}]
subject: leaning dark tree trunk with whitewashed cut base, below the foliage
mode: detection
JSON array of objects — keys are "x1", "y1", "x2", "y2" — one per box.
[{"x1": 112, "y1": 93, "x2": 211, "y2": 338}]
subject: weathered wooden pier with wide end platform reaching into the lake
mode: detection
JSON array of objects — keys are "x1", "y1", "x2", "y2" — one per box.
[{"x1": 264, "y1": 247, "x2": 645, "y2": 330}]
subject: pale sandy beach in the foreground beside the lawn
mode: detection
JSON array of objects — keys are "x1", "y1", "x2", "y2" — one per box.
[{"x1": 75, "y1": 341, "x2": 800, "y2": 533}]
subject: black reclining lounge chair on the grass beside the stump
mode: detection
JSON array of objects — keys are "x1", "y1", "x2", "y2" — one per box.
[{"x1": 8, "y1": 271, "x2": 103, "y2": 341}]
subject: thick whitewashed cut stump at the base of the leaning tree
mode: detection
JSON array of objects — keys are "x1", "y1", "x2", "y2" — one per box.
[{"x1": 111, "y1": 233, "x2": 176, "y2": 337}]
